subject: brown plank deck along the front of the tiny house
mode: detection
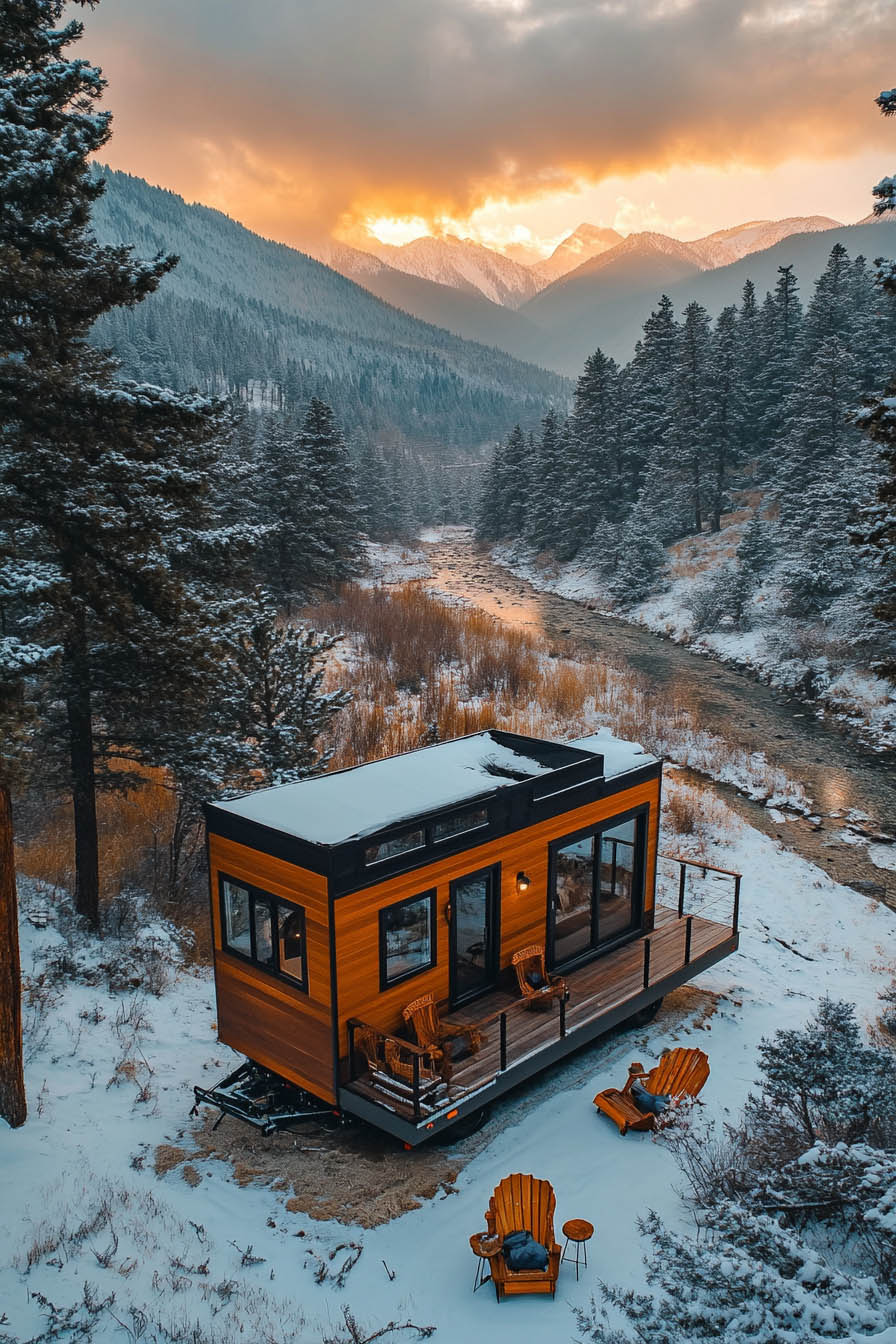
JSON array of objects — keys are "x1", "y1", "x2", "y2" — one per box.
[{"x1": 341, "y1": 906, "x2": 737, "y2": 1133}]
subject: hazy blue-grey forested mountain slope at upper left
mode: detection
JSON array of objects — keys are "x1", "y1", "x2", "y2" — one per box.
[{"x1": 94, "y1": 171, "x2": 568, "y2": 473}]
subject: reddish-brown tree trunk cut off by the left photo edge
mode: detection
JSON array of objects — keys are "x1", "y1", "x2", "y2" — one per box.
[{"x1": 0, "y1": 784, "x2": 27, "y2": 1129}]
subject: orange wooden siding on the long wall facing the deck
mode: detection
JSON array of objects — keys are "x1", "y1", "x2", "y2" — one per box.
[{"x1": 333, "y1": 780, "x2": 660, "y2": 1055}]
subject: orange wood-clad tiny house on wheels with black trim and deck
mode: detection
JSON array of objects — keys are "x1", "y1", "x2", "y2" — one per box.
[{"x1": 197, "y1": 730, "x2": 740, "y2": 1145}]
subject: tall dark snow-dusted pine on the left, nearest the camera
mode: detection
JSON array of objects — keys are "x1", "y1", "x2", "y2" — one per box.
[{"x1": 0, "y1": 0, "x2": 229, "y2": 923}]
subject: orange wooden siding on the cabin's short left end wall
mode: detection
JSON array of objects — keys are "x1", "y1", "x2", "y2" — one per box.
[{"x1": 208, "y1": 835, "x2": 336, "y2": 1102}]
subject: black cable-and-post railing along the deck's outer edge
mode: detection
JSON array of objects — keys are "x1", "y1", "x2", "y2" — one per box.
[{"x1": 348, "y1": 853, "x2": 742, "y2": 1121}]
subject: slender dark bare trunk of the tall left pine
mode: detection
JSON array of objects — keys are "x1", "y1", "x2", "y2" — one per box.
[{"x1": 66, "y1": 609, "x2": 99, "y2": 929}]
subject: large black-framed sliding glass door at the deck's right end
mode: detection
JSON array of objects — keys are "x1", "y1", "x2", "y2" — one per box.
[{"x1": 548, "y1": 813, "x2": 646, "y2": 966}]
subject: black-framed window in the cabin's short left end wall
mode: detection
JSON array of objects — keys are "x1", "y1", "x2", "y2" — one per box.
[{"x1": 220, "y1": 876, "x2": 308, "y2": 989}]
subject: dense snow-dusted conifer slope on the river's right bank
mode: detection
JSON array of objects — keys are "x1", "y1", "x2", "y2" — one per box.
[{"x1": 478, "y1": 243, "x2": 896, "y2": 704}]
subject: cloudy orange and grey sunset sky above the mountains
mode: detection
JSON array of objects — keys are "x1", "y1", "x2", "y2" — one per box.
[{"x1": 78, "y1": 0, "x2": 896, "y2": 254}]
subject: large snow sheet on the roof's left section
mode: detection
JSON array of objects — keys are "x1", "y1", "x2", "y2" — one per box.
[{"x1": 215, "y1": 732, "x2": 600, "y2": 844}]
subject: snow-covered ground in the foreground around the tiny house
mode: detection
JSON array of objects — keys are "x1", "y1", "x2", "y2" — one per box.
[{"x1": 0, "y1": 804, "x2": 896, "y2": 1344}]
